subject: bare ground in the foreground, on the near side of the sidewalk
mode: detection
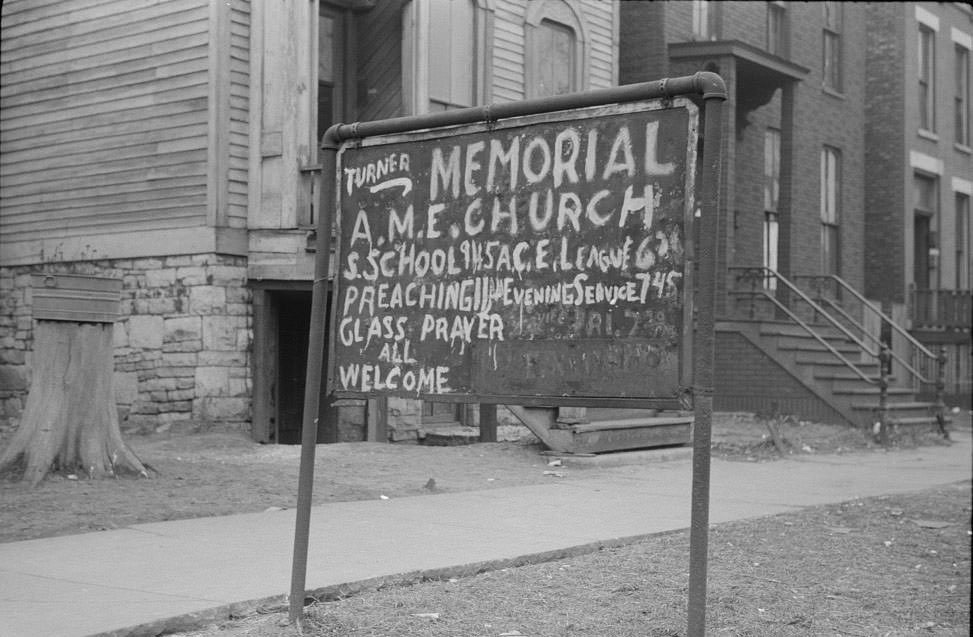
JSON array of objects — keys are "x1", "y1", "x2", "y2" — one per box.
[{"x1": 187, "y1": 481, "x2": 971, "y2": 637}]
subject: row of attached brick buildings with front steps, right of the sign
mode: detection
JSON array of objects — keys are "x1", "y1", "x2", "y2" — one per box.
[{"x1": 619, "y1": 1, "x2": 973, "y2": 423}]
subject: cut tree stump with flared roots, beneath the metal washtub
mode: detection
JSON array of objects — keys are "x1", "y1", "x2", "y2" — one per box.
[{"x1": 0, "y1": 320, "x2": 148, "y2": 485}]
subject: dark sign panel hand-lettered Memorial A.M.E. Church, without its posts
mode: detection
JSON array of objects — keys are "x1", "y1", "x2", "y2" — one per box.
[{"x1": 329, "y1": 98, "x2": 697, "y2": 407}]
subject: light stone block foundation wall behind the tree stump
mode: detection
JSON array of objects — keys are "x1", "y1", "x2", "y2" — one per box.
[{"x1": 0, "y1": 254, "x2": 252, "y2": 430}]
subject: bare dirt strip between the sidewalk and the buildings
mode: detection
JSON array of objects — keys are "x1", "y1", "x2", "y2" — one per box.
[{"x1": 0, "y1": 414, "x2": 956, "y2": 542}]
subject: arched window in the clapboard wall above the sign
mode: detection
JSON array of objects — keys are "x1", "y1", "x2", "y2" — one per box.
[{"x1": 524, "y1": 0, "x2": 588, "y2": 97}]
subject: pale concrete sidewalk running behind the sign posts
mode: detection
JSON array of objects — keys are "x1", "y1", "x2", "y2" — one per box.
[{"x1": 0, "y1": 431, "x2": 973, "y2": 637}]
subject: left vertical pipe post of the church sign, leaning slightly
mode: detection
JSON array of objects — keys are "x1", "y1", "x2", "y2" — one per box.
[{"x1": 289, "y1": 127, "x2": 338, "y2": 622}]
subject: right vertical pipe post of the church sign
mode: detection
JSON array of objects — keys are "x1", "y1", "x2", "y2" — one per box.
[{"x1": 687, "y1": 84, "x2": 726, "y2": 637}]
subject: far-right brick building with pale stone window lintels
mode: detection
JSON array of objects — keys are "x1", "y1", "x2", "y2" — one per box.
[{"x1": 865, "y1": 2, "x2": 973, "y2": 408}]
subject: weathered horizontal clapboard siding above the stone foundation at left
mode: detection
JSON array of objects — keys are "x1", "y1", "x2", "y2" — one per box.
[{"x1": 0, "y1": 0, "x2": 249, "y2": 264}]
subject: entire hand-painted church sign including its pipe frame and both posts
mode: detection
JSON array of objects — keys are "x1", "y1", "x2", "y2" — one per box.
[{"x1": 290, "y1": 72, "x2": 726, "y2": 635}]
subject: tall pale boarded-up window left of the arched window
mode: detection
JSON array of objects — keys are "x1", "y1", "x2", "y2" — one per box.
[{"x1": 429, "y1": 0, "x2": 476, "y2": 111}]
